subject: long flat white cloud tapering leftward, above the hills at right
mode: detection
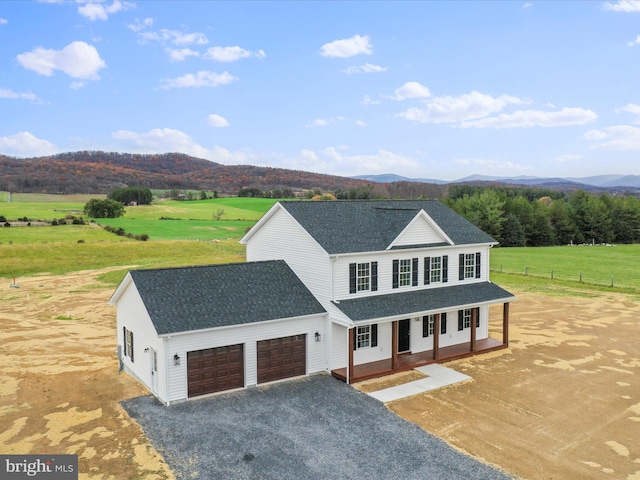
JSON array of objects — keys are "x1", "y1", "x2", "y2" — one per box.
[{"x1": 460, "y1": 107, "x2": 598, "y2": 128}]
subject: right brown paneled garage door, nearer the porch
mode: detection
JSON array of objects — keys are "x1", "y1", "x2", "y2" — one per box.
[{"x1": 258, "y1": 335, "x2": 307, "y2": 383}]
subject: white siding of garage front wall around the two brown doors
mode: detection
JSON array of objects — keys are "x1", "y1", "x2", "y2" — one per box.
[{"x1": 165, "y1": 315, "x2": 329, "y2": 402}]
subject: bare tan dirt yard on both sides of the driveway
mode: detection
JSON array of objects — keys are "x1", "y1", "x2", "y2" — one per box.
[{"x1": 0, "y1": 270, "x2": 640, "y2": 480}]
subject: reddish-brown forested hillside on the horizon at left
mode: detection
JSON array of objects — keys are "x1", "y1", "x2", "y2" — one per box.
[{"x1": 0, "y1": 151, "x2": 371, "y2": 194}]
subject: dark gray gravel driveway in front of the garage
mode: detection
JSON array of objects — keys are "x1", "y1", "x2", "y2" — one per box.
[{"x1": 123, "y1": 375, "x2": 510, "y2": 480}]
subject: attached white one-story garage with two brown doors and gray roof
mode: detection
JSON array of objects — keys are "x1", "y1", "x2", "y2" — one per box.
[{"x1": 110, "y1": 260, "x2": 329, "y2": 405}]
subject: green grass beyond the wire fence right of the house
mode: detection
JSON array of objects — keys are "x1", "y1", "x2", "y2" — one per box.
[{"x1": 491, "y1": 245, "x2": 640, "y2": 290}]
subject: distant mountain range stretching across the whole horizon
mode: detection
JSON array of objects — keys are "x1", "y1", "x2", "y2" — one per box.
[{"x1": 0, "y1": 151, "x2": 640, "y2": 198}]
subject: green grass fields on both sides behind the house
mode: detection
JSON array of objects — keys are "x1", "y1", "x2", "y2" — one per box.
[{"x1": 0, "y1": 192, "x2": 640, "y2": 294}]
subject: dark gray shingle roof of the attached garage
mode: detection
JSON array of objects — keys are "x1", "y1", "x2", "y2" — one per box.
[{"x1": 130, "y1": 260, "x2": 325, "y2": 335}]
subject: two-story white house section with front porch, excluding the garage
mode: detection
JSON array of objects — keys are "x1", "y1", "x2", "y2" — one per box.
[{"x1": 241, "y1": 200, "x2": 515, "y2": 382}]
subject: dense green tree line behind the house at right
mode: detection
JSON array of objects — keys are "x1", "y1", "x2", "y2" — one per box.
[{"x1": 444, "y1": 185, "x2": 640, "y2": 247}]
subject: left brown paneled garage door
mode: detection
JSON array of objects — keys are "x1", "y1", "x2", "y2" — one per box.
[{"x1": 187, "y1": 344, "x2": 244, "y2": 397}]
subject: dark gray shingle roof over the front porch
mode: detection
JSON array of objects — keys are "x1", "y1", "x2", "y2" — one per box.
[{"x1": 334, "y1": 282, "x2": 515, "y2": 322}]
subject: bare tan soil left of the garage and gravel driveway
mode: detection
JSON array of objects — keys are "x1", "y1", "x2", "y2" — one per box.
[{"x1": 0, "y1": 267, "x2": 174, "y2": 480}]
